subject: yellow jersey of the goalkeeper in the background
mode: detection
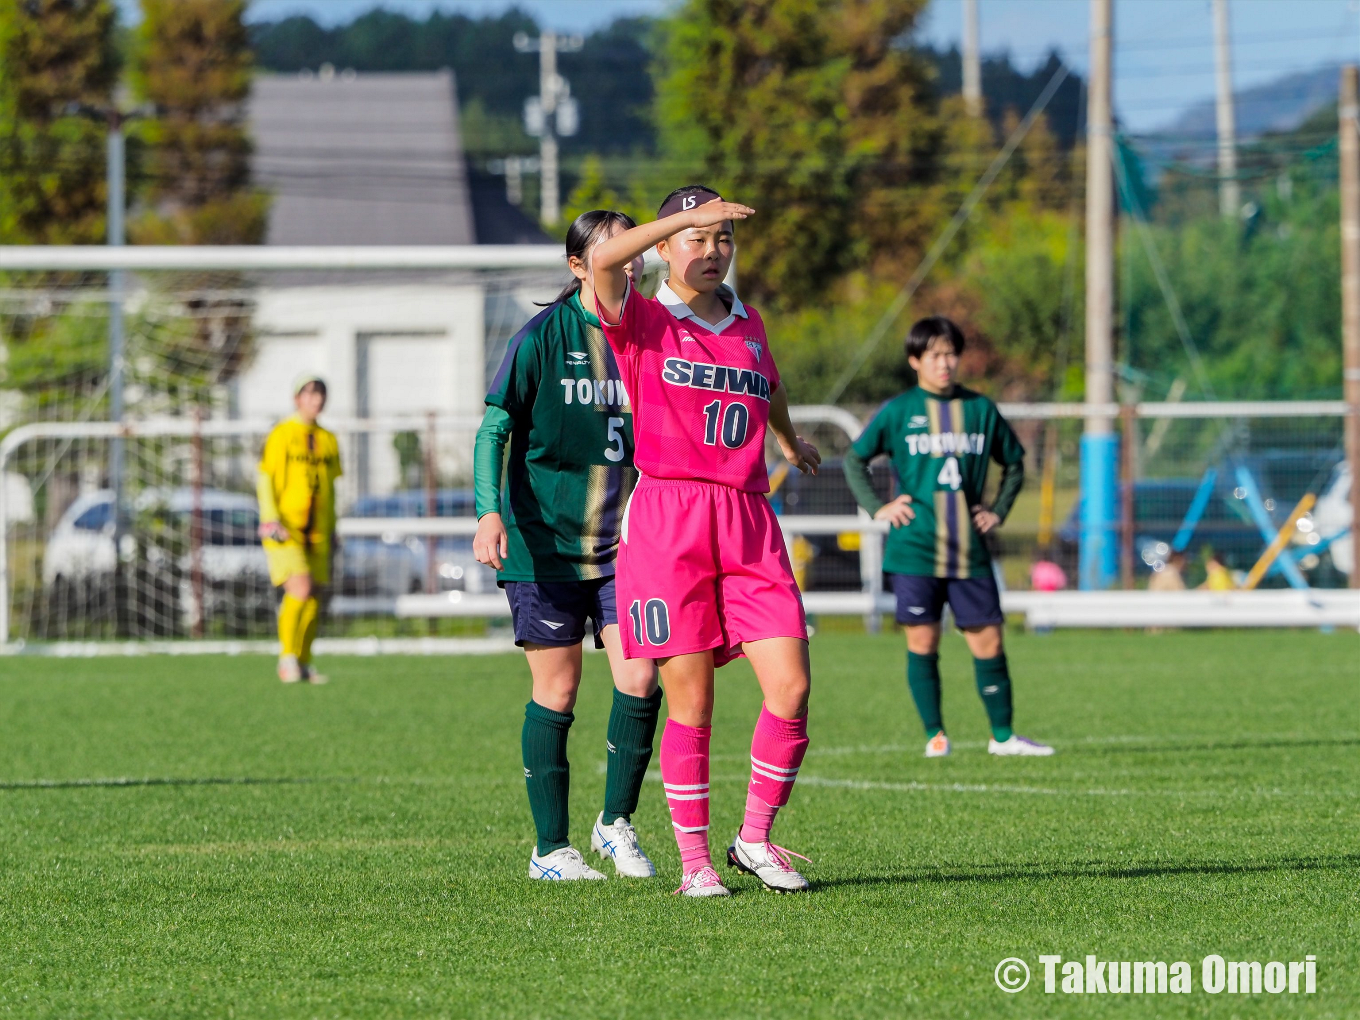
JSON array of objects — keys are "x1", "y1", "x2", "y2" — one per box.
[{"x1": 260, "y1": 415, "x2": 343, "y2": 541}]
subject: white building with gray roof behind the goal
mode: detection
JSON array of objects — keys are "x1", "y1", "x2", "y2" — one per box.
[{"x1": 234, "y1": 71, "x2": 556, "y2": 498}]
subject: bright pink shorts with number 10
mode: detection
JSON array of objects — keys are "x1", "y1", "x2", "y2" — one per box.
[{"x1": 616, "y1": 476, "x2": 808, "y2": 666}]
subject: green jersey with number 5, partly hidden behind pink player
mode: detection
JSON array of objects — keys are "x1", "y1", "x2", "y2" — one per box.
[{"x1": 487, "y1": 294, "x2": 638, "y2": 581}]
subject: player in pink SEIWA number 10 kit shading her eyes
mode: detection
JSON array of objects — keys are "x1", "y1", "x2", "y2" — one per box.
[{"x1": 592, "y1": 185, "x2": 821, "y2": 896}]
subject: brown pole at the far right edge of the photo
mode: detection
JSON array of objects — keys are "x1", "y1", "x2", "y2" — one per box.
[{"x1": 1337, "y1": 64, "x2": 1360, "y2": 588}]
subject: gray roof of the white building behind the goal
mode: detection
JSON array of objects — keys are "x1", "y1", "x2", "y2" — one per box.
[{"x1": 250, "y1": 71, "x2": 476, "y2": 245}]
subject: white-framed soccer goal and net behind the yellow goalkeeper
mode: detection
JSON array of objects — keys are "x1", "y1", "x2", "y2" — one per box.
[{"x1": 0, "y1": 246, "x2": 568, "y2": 643}]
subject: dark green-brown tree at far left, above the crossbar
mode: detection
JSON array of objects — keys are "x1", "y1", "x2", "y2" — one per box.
[{"x1": 0, "y1": 0, "x2": 118, "y2": 245}]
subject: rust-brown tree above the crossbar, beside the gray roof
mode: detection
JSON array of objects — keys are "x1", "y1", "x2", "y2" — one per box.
[{"x1": 131, "y1": 0, "x2": 268, "y2": 245}]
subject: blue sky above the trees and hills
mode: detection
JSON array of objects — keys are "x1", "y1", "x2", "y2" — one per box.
[{"x1": 121, "y1": 0, "x2": 1360, "y2": 132}]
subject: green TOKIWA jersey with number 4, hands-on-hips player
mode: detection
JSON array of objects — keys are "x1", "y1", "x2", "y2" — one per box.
[{"x1": 854, "y1": 386, "x2": 1024, "y2": 578}]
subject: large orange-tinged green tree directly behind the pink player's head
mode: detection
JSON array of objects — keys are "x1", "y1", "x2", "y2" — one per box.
[{"x1": 658, "y1": 0, "x2": 938, "y2": 305}]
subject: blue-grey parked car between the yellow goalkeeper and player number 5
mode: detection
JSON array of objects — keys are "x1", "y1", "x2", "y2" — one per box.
[{"x1": 339, "y1": 488, "x2": 496, "y2": 597}]
